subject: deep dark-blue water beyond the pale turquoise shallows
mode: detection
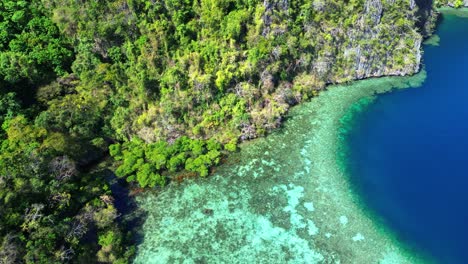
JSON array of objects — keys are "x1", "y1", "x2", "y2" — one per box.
[{"x1": 348, "y1": 11, "x2": 468, "y2": 264}]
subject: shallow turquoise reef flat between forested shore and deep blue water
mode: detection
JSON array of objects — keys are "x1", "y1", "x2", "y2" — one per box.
[{"x1": 135, "y1": 72, "x2": 432, "y2": 264}]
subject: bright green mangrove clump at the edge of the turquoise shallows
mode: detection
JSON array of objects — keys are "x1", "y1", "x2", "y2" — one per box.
[{"x1": 110, "y1": 136, "x2": 222, "y2": 187}]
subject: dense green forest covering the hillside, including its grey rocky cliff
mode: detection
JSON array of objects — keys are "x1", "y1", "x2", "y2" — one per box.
[{"x1": 0, "y1": 0, "x2": 442, "y2": 263}]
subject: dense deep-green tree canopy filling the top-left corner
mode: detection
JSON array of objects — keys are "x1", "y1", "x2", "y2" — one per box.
[{"x1": 0, "y1": 0, "x2": 73, "y2": 84}]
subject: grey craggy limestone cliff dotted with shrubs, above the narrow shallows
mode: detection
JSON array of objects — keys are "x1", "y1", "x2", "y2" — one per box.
[{"x1": 313, "y1": 0, "x2": 423, "y2": 83}]
